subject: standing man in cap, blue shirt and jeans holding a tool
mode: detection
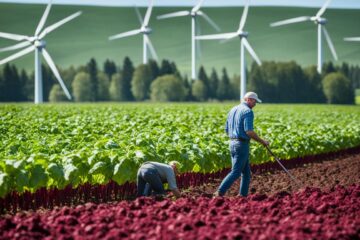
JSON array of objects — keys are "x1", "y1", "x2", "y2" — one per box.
[{"x1": 214, "y1": 92, "x2": 269, "y2": 197}]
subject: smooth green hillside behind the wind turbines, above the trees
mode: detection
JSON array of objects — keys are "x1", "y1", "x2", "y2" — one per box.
[{"x1": 0, "y1": 3, "x2": 360, "y2": 74}]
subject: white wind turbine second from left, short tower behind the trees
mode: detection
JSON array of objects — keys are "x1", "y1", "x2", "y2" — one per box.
[{"x1": 109, "y1": 0, "x2": 158, "y2": 64}]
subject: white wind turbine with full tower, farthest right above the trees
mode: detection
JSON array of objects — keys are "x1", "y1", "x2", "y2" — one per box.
[{"x1": 270, "y1": 0, "x2": 338, "y2": 73}]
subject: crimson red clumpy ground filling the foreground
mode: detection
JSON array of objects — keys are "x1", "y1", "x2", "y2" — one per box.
[{"x1": 0, "y1": 185, "x2": 360, "y2": 240}]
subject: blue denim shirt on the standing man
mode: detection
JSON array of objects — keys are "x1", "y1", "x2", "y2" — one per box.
[{"x1": 225, "y1": 102, "x2": 254, "y2": 140}]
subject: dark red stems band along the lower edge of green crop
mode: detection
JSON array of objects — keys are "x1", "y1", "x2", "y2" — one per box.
[{"x1": 0, "y1": 146, "x2": 360, "y2": 214}]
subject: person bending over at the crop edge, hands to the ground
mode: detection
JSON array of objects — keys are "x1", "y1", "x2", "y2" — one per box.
[{"x1": 137, "y1": 161, "x2": 181, "y2": 198}]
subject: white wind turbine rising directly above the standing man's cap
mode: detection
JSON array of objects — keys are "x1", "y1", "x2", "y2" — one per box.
[{"x1": 196, "y1": 0, "x2": 261, "y2": 99}]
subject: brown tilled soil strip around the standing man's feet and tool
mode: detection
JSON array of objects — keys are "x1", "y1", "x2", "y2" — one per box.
[{"x1": 185, "y1": 154, "x2": 360, "y2": 197}]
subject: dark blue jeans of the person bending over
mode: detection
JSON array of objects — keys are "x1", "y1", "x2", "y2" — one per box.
[{"x1": 137, "y1": 166, "x2": 165, "y2": 197}]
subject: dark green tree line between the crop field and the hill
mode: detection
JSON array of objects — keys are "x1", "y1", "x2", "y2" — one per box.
[{"x1": 0, "y1": 57, "x2": 360, "y2": 104}]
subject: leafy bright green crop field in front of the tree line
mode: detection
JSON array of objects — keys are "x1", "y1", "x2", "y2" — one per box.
[{"x1": 0, "y1": 103, "x2": 360, "y2": 196}]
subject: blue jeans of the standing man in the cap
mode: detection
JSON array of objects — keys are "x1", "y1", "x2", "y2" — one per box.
[{"x1": 218, "y1": 140, "x2": 251, "y2": 197}]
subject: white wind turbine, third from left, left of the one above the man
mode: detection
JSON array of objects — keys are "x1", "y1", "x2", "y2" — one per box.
[{"x1": 157, "y1": 0, "x2": 220, "y2": 79}]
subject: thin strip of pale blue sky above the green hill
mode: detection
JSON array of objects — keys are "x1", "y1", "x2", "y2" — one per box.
[{"x1": 0, "y1": 0, "x2": 360, "y2": 9}]
